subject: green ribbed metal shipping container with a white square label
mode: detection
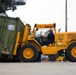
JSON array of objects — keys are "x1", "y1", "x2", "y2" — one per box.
[{"x1": 0, "y1": 16, "x2": 25, "y2": 60}]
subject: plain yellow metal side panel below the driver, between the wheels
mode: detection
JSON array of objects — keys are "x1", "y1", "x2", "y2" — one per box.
[{"x1": 41, "y1": 46, "x2": 57, "y2": 54}]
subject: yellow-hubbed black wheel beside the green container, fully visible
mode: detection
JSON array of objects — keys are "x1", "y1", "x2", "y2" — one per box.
[{"x1": 19, "y1": 44, "x2": 39, "y2": 62}]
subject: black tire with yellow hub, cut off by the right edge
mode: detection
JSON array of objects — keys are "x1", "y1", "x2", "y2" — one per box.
[{"x1": 65, "y1": 42, "x2": 76, "y2": 62}]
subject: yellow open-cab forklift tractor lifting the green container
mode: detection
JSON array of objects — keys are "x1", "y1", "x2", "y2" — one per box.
[{"x1": 13, "y1": 23, "x2": 76, "y2": 62}]
